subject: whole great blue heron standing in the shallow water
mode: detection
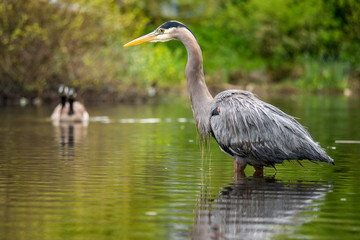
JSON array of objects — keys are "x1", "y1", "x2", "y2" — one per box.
[{"x1": 124, "y1": 21, "x2": 334, "y2": 175}]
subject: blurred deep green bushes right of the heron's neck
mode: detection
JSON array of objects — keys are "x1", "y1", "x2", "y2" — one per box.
[{"x1": 200, "y1": 0, "x2": 360, "y2": 89}]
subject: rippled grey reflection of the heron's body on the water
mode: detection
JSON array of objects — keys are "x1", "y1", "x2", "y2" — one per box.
[{"x1": 192, "y1": 177, "x2": 332, "y2": 239}]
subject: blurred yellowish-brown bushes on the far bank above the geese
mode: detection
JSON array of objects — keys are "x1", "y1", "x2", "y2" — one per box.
[{"x1": 0, "y1": 0, "x2": 145, "y2": 96}]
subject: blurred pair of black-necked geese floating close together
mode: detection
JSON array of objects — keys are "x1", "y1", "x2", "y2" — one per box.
[{"x1": 51, "y1": 85, "x2": 89, "y2": 123}]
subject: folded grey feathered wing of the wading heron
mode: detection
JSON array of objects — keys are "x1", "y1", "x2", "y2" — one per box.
[{"x1": 210, "y1": 90, "x2": 331, "y2": 166}]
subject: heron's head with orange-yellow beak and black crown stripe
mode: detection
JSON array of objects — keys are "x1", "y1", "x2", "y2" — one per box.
[{"x1": 124, "y1": 21, "x2": 191, "y2": 47}]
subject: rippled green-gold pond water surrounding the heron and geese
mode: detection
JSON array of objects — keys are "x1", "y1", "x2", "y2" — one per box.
[{"x1": 0, "y1": 96, "x2": 360, "y2": 240}]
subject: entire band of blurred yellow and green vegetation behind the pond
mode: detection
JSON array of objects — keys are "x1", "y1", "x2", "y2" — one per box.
[{"x1": 0, "y1": 0, "x2": 360, "y2": 104}]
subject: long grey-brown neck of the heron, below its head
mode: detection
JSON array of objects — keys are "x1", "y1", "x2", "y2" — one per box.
[{"x1": 178, "y1": 29, "x2": 213, "y2": 138}]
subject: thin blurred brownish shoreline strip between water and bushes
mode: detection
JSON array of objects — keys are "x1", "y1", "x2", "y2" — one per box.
[{"x1": 0, "y1": 82, "x2": 360, "y2": 106}]
